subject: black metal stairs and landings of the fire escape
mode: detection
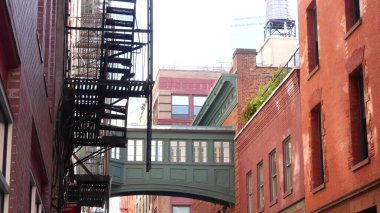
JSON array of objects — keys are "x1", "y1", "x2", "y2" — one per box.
[{"x1": 65, "y1": 0, "x2": 153, "y2": 206}]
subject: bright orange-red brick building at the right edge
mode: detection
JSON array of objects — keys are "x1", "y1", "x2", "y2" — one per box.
[{"x1": 298, "y1": 0, "x2": 380, "y2": 212}]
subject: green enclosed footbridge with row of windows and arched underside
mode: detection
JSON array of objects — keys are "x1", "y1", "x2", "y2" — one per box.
[{"x1": 109, "y1": 126, "x2": 235, "y2": 204}]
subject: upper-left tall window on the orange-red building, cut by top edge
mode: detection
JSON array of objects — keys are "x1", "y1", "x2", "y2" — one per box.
[{"x1": 307, "y1": 0, "x2": 319, "y2": 72}]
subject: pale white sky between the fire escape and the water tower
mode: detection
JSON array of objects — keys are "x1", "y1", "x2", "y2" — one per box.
[{"x1": 128, "y1": 0, "x2": 297, "y2": 123}]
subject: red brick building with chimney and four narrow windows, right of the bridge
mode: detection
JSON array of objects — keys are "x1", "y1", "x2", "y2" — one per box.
[{"x1": 235, "y1": 50, "x2": 304, "y2": 212}]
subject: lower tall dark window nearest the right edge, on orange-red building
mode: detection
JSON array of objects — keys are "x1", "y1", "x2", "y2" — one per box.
[{"x1": 349, "y1": 65, "x2": 368, "y2": 164}]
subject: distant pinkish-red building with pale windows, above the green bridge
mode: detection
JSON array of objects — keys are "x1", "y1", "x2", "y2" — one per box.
[{"x1": 153, "y1": 69, "x2": 221, "y2": 125}]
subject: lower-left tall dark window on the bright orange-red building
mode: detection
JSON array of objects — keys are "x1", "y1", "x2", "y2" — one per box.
[{"x1": 311, "y1": 105, "x2": 324, "y2": 188}]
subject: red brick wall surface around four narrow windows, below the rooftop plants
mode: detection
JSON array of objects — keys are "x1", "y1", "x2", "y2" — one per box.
[{"x1": 235, "y1": 70, "x2": 304, "y2": 212}]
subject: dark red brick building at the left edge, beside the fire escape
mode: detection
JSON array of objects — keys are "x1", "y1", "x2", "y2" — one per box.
[{"x1": 0, "y1": 0, "x2": 63, "y2": 213}]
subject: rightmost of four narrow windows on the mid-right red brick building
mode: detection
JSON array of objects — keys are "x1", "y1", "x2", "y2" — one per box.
[{"x1": 283, "y1": 137, "x2": 292, "y2": 193}]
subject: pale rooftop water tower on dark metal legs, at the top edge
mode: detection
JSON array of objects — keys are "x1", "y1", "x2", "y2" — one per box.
[{"x1": 264, "y1": 0, "x2": 296, "y2": 40}]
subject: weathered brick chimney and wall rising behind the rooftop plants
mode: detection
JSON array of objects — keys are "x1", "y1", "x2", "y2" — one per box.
[{"x1": 230, "y1": 49, "x2": 276, "y2": 132}]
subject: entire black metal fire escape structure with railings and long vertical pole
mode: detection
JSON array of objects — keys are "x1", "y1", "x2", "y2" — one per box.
[{"x1": 61, "y1": 0, "x2": 154, "y2": 210}]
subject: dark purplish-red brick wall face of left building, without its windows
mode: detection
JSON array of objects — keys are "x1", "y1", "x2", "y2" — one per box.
[{"x1": 2, "y1": 0, "x2": 59, "y2": 213}]
